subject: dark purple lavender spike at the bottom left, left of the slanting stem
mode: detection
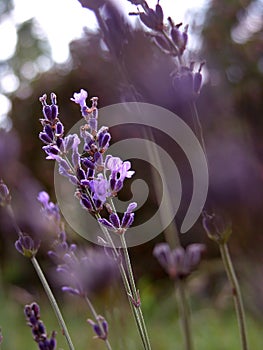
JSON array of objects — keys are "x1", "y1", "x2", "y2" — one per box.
[{"x1": 24, "y1": 303, "x2": 56, "y2": 350}]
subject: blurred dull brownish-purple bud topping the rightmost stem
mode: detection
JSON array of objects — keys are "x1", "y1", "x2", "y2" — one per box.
[{"x1": 202, "y1": 211, "x2": 232, "y2": 244}]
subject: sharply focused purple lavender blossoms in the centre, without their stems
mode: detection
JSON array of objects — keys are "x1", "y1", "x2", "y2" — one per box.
[{"x1": 39, "y1": 89, "x2": 136, "y2": 237}]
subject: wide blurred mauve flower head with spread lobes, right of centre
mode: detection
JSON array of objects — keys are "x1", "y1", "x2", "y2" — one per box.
[{"x1": 153, "y1": 243, "x2": 205, "y2": 280}]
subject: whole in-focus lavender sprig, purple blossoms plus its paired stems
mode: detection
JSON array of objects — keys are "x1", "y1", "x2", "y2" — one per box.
[{"x1": 39, "y1": 89, "x2": 151, "y2": 349}]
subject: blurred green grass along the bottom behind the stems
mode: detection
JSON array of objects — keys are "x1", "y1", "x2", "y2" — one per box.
[{"x1": 0, "y1": 281, "x2": 263, "y2": 350}]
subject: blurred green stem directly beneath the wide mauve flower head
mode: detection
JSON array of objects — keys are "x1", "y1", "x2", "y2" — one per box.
[{"x1": 176, "y1": 280, "x2": 193, "y2": 350}]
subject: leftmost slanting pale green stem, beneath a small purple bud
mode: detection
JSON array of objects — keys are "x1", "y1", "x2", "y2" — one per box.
[{"x1": 31, "y1": 256, "x2": 74, "y2": 350}]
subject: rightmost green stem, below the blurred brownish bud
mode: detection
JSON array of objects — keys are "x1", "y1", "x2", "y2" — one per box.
[{"x1": 219, "y1": 243, "x2": 248, "y2": 350}]
